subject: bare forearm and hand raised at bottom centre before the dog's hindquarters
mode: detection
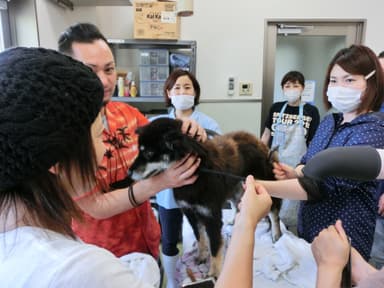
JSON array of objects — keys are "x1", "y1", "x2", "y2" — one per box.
[{"x1": 215, "y1": 176, "x2": 272, "y2": 288}]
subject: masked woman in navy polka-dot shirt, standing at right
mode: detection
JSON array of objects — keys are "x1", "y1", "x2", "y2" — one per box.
[{"x1": 258, "y1": 45, "x2": 384, "y2": 260}]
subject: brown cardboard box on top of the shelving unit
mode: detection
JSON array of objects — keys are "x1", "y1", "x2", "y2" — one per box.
[{"x1": 133, "y1": 1, "x2": 180, "y2": 40}]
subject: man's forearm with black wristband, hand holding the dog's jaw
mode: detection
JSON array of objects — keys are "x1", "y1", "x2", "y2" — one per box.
[{"x1": 76, "y1": 156, "x2": 200, "y2": 219}]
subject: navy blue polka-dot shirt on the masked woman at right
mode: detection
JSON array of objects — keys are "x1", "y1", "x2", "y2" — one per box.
[{"x1": 298, "y1": 113, "x2": 384, "y2": 259}]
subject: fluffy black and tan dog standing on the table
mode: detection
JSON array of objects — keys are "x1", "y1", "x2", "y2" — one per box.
[{"x1": 131, "y1": 118, "x2": 281, "y2": 277}]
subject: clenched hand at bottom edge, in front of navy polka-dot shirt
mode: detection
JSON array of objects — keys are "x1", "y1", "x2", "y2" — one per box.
[{"x1": 311, "y1": 220, "x2": 350, "y2": 288}]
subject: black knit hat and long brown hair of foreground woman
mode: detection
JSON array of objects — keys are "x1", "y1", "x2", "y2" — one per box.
[{"x1": 0, "y1": 47, "x2": 104, "y2": 238}]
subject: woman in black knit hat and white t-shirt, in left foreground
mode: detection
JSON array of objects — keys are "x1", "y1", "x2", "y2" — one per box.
[{"x1": 0, "y1": 48, "x2": 159, "y2": 287}]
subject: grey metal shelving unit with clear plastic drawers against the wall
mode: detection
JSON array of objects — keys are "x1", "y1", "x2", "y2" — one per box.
[{"x1": 108, "y1": 39, "x2": 196, "y2": 114}]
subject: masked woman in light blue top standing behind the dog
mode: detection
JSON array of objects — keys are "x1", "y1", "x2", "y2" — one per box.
[{"x1": 150, "y1": 69, "x2": 220, "y2": 288}]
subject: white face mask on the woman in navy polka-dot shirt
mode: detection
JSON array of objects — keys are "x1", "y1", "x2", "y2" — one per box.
[{"x1": 327, "y1": 86, "x2": 362, "y2": 113}]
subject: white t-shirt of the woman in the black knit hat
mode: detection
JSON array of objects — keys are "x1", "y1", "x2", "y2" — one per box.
[{"x1": 0, "y1": 227, "x2": 159, "y2": 288}]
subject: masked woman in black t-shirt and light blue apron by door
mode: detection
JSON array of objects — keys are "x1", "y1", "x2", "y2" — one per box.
[{"x1": 261, "y1": 71, "x2": 320, "y2": 234}]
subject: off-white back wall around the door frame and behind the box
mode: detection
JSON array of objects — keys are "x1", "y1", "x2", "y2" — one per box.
[{"x1": 33, "y1": 0, "x2": 384, "y2": 134}]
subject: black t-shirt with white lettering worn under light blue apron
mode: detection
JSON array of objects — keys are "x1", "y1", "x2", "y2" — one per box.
[{"x1": 265, "y1": 101, "x2": 320, "y2": 146}]
